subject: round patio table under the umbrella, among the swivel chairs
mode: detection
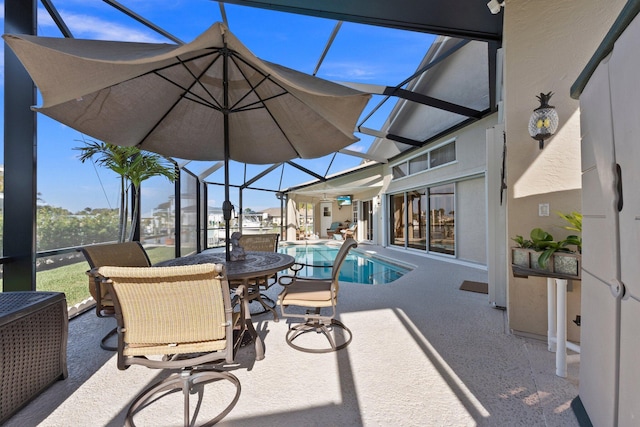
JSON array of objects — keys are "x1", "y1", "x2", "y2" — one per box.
[{"x1": 155, "y1": 250, "x2": 295, "y2": 360}]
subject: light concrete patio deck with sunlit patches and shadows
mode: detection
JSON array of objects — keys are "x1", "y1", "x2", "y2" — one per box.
[{"x1": 5, "y1": 245, "x2": 579, "y2": 427}]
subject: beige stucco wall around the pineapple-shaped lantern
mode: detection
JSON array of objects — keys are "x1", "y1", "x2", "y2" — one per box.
[{"x1": 503, "y1": 0, "x2": 625, "y2": 341}]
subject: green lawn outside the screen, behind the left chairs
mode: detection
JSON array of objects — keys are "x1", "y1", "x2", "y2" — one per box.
[{"x1": 36, "y1": 246, "x2": 174, "y2": 306}]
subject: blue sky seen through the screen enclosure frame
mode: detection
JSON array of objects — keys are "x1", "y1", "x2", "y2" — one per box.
[{"x1": 0, "y1": 0, "x2": 434, "y2": 211}]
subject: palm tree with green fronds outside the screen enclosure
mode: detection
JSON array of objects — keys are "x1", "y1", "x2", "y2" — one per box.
[{"x1": 74, "y1": 141, "x2": 176, "y2": 242}]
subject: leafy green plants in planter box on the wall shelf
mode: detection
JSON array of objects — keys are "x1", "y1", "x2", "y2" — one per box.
[{"x1": 512, "y1": 212, "x2": 582, "y2": 279}]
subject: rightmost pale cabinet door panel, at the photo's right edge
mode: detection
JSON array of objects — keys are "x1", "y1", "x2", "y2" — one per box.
[{"x1": 609, "y1": 11, "x2": 640, "y2": 426}]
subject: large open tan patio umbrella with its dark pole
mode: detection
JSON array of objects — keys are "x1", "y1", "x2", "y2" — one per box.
[{"x1": 3, "y1": 23, "x2": 370, "y2": 260}]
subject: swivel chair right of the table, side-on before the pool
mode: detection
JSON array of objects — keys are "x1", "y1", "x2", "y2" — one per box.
[{"x1": 278, "y1": 238, "x2": 358, "y2": 353}]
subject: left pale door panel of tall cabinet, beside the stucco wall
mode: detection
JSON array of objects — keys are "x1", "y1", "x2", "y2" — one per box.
[{"x1": 580, "y1": 49, "x2": 620, "y2": 426}]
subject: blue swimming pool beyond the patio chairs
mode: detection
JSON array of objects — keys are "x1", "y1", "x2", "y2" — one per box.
[{"x1": 278, "y1": 244, "x2": 411, "y2": 285}]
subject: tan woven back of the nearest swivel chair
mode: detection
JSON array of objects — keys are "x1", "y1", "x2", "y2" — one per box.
[{"x1": 97, "y1": 264, "x2": 233, "y2": 369}]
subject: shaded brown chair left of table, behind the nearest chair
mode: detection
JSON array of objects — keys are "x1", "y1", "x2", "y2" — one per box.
[{"x1": 81, "y1": 242, "x2": 151, "y2": 351}]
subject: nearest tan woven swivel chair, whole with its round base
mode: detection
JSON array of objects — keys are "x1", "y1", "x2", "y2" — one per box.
[{"x1": 94, "y1": 264, "x2": 241, "y2": 426}]
